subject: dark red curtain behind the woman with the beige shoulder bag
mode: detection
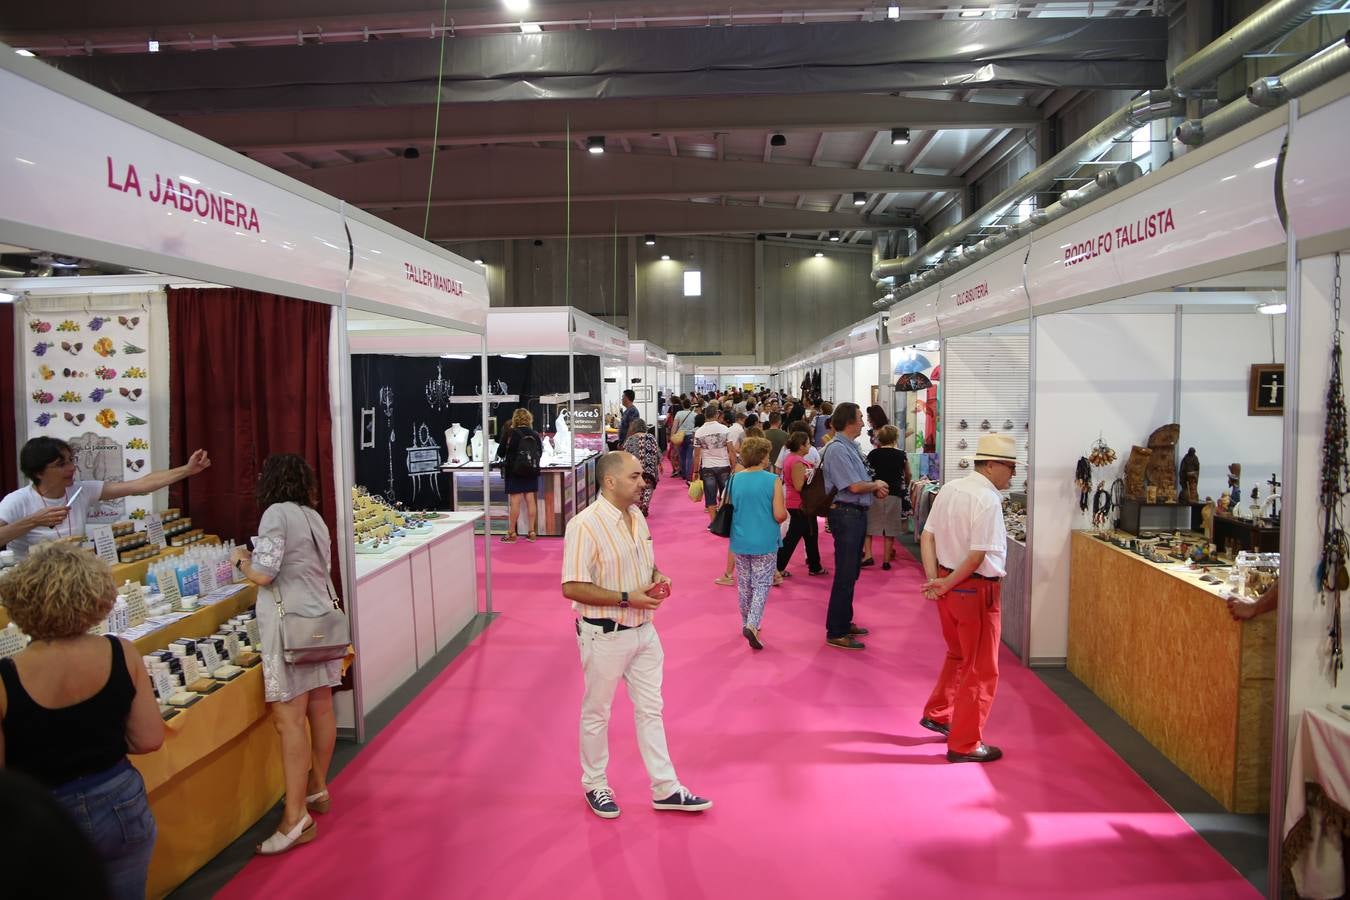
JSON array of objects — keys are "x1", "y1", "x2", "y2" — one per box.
[{"x1": 169, "y1": 289, "x2": 340, "y2": 569}]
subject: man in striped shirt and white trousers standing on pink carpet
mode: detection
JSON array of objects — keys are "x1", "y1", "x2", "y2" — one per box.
[{"x1": 563, "y1": 451, "x2": 713, "y2": 819}]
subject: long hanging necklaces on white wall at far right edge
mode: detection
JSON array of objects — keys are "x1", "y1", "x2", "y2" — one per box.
[{"x1": 1318, "y1": 254, "x2": 1350, "y2": 685}]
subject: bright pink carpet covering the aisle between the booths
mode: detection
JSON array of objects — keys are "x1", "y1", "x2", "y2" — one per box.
[{"x1": 220, "y1": 464, "x2": 1260, "y2": 900}]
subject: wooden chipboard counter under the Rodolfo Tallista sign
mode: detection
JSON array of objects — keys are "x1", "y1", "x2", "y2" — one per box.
[{"x1": 1068, "y1": 532, "x2": 1276, "y2": 812}]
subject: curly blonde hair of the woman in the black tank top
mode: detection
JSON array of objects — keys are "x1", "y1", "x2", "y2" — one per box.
[{"x1": 0, "y1": 544, "x2": 117, "y2": 641}]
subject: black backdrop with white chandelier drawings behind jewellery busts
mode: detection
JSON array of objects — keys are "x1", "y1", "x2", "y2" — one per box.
[{"x1": 351, "y1": 354, "x2": 601, "y2": 509}]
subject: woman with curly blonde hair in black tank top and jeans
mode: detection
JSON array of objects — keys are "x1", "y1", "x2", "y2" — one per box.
[{"x1": 0, "y1": 544, "x2": 163, "y2": 900}]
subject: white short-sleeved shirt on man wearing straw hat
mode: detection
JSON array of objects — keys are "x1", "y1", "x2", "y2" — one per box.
[{"x1": 923, "y1": 472, "x2": 1008, "y2": 578}]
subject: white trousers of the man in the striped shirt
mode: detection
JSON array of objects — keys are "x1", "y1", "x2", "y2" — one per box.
[{"x1": 576, "y1": 619, "x2": 680, "y2": 800}]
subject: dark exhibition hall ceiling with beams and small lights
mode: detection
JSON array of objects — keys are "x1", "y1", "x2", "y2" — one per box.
[{"x1": 0, "y1": 0, "x2": 1168, "y2": 243}]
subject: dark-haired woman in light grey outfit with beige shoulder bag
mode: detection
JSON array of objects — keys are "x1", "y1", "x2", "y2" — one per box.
[{"x1": 232, "y1": 453, "x2": 343, "y2": 855}]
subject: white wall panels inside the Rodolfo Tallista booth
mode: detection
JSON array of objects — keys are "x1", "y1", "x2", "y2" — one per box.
[{"x1": 1031, "y1": 293, "x2": 1284, "y2": 664}]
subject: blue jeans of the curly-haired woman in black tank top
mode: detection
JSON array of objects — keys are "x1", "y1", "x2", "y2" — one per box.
[{"x1": 51, "y1": 760, "x2": 155, "y2": 900}]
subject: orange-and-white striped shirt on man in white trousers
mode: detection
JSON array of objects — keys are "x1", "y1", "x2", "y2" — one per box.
[{"x1": 563, "y1": 495, "x2": 656, "y2": 625}]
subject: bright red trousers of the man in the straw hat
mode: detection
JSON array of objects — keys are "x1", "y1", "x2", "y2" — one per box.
[{"x1": 923, "y1": 571, "x2": 1002, "y2": 753}]
